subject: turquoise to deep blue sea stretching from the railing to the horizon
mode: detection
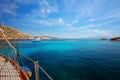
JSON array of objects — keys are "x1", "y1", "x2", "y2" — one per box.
[{"x1": 17, "y1": 40, "x2": 120, "y2": 80}]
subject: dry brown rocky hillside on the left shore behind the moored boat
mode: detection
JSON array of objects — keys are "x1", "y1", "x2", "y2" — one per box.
[{"x1": 0, "y1": 25, "x2": 57, "y2": 40}]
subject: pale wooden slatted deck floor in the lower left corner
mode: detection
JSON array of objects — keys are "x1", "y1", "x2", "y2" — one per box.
[{"x1": 0, "y1": 56, "x2": 21, "y2": 80}]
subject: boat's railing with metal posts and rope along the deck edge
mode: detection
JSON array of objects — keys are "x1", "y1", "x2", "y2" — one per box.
[{"x1": 0, "y1": 28, "x2": 53, "y2": 80}]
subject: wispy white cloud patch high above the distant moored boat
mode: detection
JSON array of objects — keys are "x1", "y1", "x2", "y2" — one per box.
[{"x1": 23, "y1": 0, "x2": 58, "y2": 18}]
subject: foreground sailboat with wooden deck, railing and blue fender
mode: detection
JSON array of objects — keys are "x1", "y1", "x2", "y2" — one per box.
[{"x1": 0, "y1": 0, "x2": 53, "y2": 80}]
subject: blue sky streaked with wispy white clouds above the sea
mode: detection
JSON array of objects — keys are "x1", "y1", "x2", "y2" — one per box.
[{"x1": 0, "y1": 0, "x2": 120, "y2": 38}]
